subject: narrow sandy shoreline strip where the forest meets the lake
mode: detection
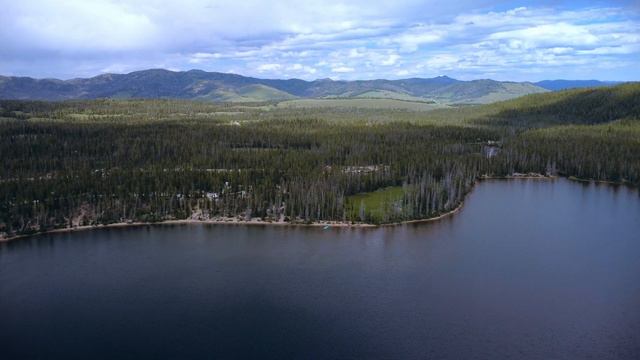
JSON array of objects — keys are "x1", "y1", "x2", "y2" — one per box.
[{"x1": 0, "y1": 173, "x2": 623, "y2": 244}]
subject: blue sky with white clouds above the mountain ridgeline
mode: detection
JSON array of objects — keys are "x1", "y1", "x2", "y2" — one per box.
[{"x1": 0, "y1": 0, "x2": 640, "y2": 81}]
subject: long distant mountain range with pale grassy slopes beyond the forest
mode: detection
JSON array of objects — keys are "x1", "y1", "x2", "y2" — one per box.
[{"x1": 0, "y1": 69, "x2": 548, "y2": 103}]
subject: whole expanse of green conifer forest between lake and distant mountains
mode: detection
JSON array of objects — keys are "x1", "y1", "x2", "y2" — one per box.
[{"x1": 0, "y1": 84, "x2": 640, "y2": 237}]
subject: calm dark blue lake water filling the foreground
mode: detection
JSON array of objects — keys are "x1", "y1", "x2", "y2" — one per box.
[{"x1": 0, "y1": 180, "x2": 640, "y2": 359}]
